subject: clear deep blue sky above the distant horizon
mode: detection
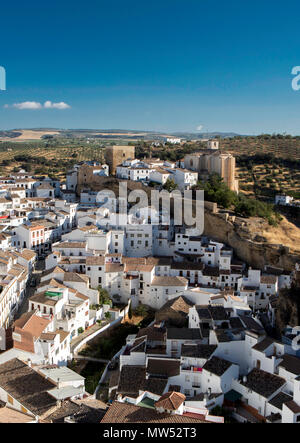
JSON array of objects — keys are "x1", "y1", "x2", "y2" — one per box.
[{"x1": 0, "y1": 0, "x2": 300, "y2": 134}]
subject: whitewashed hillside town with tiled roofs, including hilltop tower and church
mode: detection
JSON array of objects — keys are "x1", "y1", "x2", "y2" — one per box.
[{"x1": 0, "y1": 140, "x2": 300, "y2": 424}]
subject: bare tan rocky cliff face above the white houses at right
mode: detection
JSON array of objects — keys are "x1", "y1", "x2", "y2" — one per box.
[{"x1": 204, "y1": 210, "x2": 300, "y2": 271}]
